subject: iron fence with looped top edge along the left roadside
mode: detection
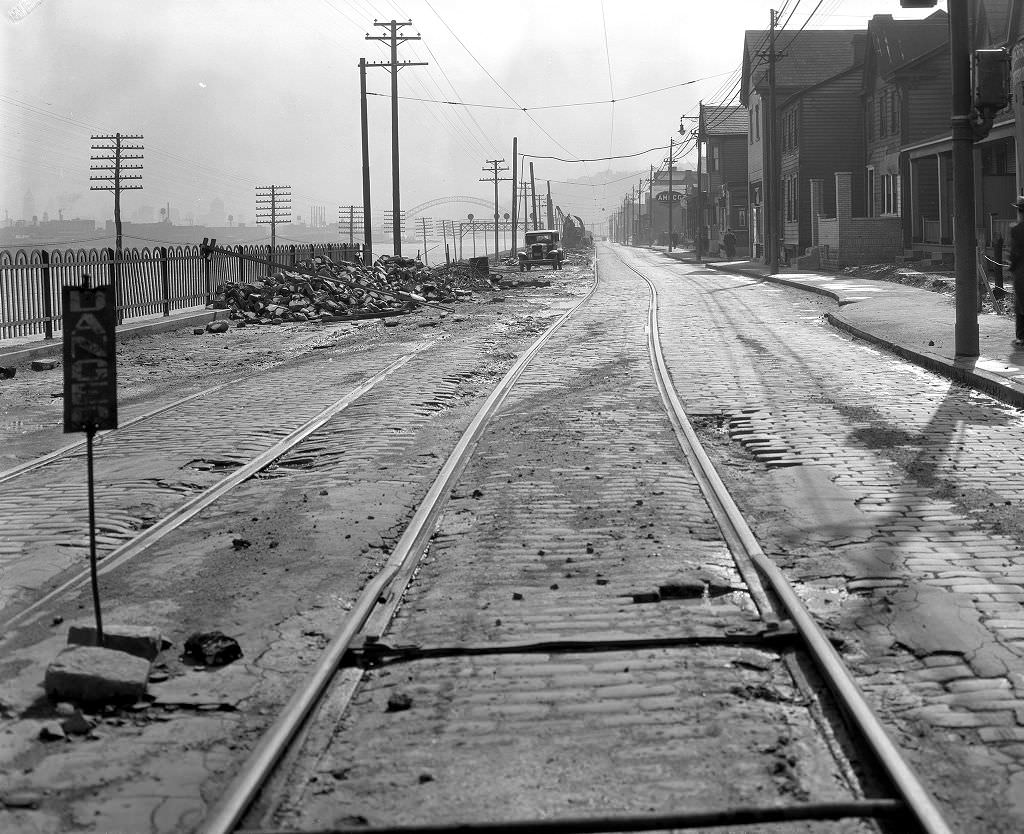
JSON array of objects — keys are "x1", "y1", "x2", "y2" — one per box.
[{"x1": 0, "y1": 243, "x2": 360, "y2": 339}]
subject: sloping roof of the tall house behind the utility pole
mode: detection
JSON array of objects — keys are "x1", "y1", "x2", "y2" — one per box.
[{"x1": 739, "y1": 29, "x2": 866, "y2": 103}]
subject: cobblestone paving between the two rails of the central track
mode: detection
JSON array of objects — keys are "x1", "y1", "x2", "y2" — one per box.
[{"x1": 272, "y1": 251, "x2": 865, "y2": 832}]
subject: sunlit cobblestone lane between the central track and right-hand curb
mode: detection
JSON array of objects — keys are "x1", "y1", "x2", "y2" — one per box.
[{"x1": 618, "y1": 250, "x2": 1024, "y2": 834}]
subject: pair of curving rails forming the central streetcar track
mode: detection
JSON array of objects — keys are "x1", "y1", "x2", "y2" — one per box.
[{"x1": 190, "y1": 249, "x2": 948, "y2": 834}]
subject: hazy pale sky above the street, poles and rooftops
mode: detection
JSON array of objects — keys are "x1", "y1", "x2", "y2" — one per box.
[{"x1": 0, "y1": 0, "x2": 945, "y2": 235}]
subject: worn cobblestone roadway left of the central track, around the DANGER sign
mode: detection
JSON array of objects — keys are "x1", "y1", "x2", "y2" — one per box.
[{"x1": 0, "y1": 270, "x2": 590, "y2": 834}]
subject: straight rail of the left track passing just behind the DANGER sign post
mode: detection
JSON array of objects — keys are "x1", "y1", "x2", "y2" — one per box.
[{"x1": 0, "y1": 339, "x2": 438, "y2": 630}]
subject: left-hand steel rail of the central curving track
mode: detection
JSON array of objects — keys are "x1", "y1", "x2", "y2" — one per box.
[{"x1": 198, "y1": 264, "x2": 598, "y2": 834}]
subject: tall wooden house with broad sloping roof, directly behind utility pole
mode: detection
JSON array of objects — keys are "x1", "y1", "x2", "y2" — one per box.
[{"x1": 739, "y1": 30, "x2": 866, "y2": 257}]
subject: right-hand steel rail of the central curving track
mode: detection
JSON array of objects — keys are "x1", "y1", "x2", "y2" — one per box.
[{"x1": 620, "y1": 246, "x2": 952, "y2": 834}]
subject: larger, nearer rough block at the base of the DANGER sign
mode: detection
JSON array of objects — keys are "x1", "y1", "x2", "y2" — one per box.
[{"x1": 44, "y1": 645, "x2": 150, "y2": 704}]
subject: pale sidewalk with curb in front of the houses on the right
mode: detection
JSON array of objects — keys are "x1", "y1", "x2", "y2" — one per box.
[{"x1": 659, "y1": 248, "x2": 1024, "y2": 408}]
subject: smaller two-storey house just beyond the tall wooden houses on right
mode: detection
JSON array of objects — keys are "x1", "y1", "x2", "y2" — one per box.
[{"x1": 697, "y1": 105, "x2": 751, "y2": 255}]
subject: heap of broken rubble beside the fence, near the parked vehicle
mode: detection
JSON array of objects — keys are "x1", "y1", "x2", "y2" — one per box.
[{"x1": 220, "y1": 256, "x2": 494, "y2": 325}]
